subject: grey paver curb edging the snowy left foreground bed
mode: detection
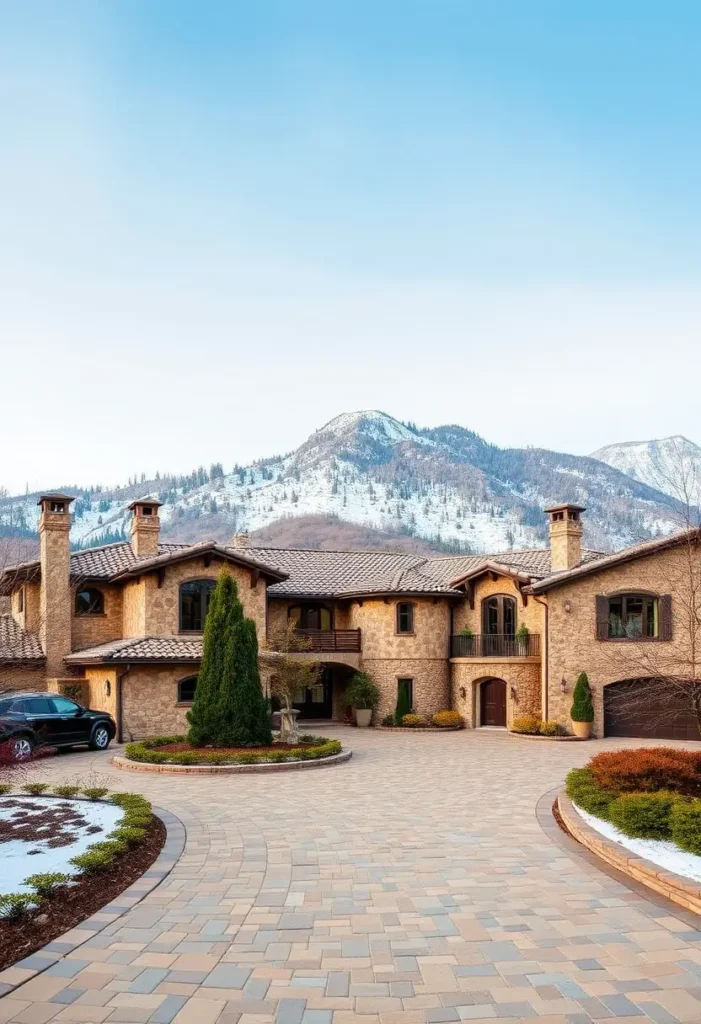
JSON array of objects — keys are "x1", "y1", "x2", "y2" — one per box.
[{"x1": 0, "y1": 807, "x2": 185, "y2": 999}]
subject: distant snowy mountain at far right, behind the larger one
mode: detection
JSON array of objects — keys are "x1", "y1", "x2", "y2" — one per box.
[{"x1": 592, "y1": 434, "x2": 701, "y2": 498}]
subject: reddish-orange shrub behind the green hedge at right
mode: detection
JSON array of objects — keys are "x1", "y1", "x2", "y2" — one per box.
[{"x1": 589, "y1": 746, "x2": 701, "y2": 797}]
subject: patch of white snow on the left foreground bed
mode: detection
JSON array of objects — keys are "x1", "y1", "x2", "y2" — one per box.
[{"x1": 0, "y1": 794, "x2": 124, "y2": 893}]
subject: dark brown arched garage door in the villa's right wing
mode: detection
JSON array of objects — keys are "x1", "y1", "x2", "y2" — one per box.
[{"x1": 604, "y1": 679, "x2": 701, "y2": 739}]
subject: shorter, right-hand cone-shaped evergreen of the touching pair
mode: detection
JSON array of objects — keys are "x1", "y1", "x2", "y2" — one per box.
[{"x1": 217, "y1": 618, "x2": 272, "y2": 746}]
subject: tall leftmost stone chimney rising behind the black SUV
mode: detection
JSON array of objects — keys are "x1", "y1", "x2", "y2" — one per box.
[{"x1": 37, "y1": 495, "x2": 75, "y2": 679}]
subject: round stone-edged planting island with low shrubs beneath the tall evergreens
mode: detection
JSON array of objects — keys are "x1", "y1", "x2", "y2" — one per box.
[{"x1": 113, "y1": 736, "x2": 352, "y2": 775}]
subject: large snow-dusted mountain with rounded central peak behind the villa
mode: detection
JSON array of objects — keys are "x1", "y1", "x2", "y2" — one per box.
[{"x1": 0, "y1": 411, "x2": 675, "y2": 552}]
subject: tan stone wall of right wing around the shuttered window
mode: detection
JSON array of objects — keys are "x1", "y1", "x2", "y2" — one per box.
[{"x1": 547, "y1": 548, "x2": 698, "y2": 735}]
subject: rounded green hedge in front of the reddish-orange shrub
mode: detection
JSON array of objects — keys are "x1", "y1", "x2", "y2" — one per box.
[{"x1": 567, "y1": 768, "x2": 701, "y2": 856}]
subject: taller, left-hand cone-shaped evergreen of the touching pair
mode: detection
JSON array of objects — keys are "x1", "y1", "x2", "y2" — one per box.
[{"x1": 187, "y1": 572, "x2": 244, "y2": 746}]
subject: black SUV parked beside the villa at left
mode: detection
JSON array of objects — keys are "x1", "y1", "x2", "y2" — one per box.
[{"x1": 0, "y1": 693, "x2": 117, "y2": 761}]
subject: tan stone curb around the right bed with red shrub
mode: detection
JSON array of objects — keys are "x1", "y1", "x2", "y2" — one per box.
[{"x1": 558, "y1": 793, "x2": 701, "y2": 913}]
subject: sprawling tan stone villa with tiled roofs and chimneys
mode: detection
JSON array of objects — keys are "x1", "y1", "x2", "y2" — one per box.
[{"x1": 0, "y1": 494, "x2": 698, "y2": 739}]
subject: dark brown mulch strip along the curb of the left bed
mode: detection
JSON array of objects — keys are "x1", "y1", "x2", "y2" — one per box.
[{"x1": 0, "y1": 816, "x2": 166, "y2": 970}]
